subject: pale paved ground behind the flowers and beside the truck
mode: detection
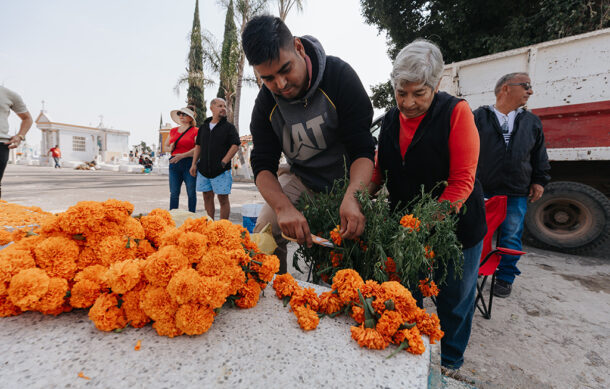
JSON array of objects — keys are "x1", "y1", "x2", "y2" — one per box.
[{"x1": 2, "y1": 165, "x2": 610, "y2": 388}]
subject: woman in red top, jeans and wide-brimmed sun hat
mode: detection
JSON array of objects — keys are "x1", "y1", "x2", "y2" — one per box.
[{"x1": 165, "y1": 106, "x2": 198, "y2": 212}]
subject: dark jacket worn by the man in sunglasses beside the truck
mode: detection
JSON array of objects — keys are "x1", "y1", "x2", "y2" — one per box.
[{"x1": 474, "y1": 105, "x2": 551, "y2": 196}]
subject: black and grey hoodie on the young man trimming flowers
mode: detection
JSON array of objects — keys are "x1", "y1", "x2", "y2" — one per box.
[{"x1": 250, "y1": 36, "x2": 375, "y2": 191}]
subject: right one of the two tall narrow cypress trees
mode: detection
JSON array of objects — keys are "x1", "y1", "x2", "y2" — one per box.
[{"x1": 217, "y1": 0, "x2": 240, "y2": 123}]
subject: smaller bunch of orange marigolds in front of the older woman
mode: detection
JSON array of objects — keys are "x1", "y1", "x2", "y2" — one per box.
[{"x1": 273, "y1": 269, "x2": 444, "y2": 356}]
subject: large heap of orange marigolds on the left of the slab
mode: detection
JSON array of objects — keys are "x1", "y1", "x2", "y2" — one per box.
[{"x1": 0, "y1": 200, "x2": 279, "y2": 337}]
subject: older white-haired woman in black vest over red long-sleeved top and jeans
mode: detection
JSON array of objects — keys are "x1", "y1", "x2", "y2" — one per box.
[{"x1": 369, "y1": 40, "x2": 487, "y2": 369}]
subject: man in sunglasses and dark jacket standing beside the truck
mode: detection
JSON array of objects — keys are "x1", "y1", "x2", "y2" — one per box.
[{"x1": 474, "y1": 73, "x2": 551, "y2": 297}]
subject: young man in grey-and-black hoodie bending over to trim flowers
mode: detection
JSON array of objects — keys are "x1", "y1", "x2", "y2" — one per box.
[{"x1": 242, "y1": 15, "x2": 375, "y2": 273}]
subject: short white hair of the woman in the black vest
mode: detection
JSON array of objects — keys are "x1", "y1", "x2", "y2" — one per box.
[{"x1": 390, "y1": 39, "x2": 445, "y2": 89}]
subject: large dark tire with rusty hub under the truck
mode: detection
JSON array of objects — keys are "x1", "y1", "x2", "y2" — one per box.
[{"x1": 525, "y1": 182, "x2": 610, "y2": 254}]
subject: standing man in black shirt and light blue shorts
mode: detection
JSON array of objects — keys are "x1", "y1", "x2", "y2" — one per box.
[{"x1": 190, "y1": 97, "x2": 240, "y2": 219}]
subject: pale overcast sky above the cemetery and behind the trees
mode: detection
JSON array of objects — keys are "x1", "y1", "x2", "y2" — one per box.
[{"x1": 0, "y1": 0, "x2": 391, "y2": 152}]
